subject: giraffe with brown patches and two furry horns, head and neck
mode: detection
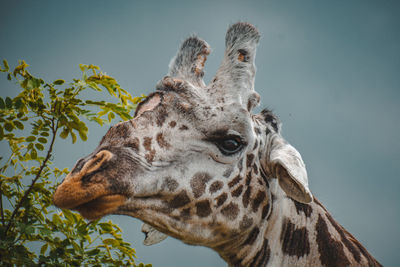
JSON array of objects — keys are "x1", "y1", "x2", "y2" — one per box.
[{"x1": 53, "y1": 22, "x2": 381, "y2": 266}]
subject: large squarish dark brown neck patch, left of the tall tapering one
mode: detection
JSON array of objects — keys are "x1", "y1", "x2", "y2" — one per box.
[{"x1": 281, "y1": 218, "x2": 310, "y2": 257}]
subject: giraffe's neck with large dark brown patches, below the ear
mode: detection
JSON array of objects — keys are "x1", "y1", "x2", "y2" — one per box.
[{"x1": 217, "y1": 182, "x2": 381, "y2": 266}]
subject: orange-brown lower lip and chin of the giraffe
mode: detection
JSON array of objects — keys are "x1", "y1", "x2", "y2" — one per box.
[{"x1": 73, "y1": 194, "x2": 126, "y2": 221}]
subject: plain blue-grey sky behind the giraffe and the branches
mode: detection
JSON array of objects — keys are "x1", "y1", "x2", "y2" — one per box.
[{"x1": 0, "y1": 0, "x2": 400, "y2": 267}]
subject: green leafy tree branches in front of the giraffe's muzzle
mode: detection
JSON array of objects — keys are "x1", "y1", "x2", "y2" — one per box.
[{"x1": 0, "y1": 60, "x2": 151, "y2": 267}]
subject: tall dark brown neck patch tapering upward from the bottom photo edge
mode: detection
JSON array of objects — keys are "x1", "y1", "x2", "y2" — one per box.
[{"x1": 316, "y1": 215, "x2": 350, "y2": 267}]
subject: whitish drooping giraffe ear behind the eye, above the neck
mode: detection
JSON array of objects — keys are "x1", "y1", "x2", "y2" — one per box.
[{"x1": 268, "y1": 134, "x2": 313, "y2": 203}]
